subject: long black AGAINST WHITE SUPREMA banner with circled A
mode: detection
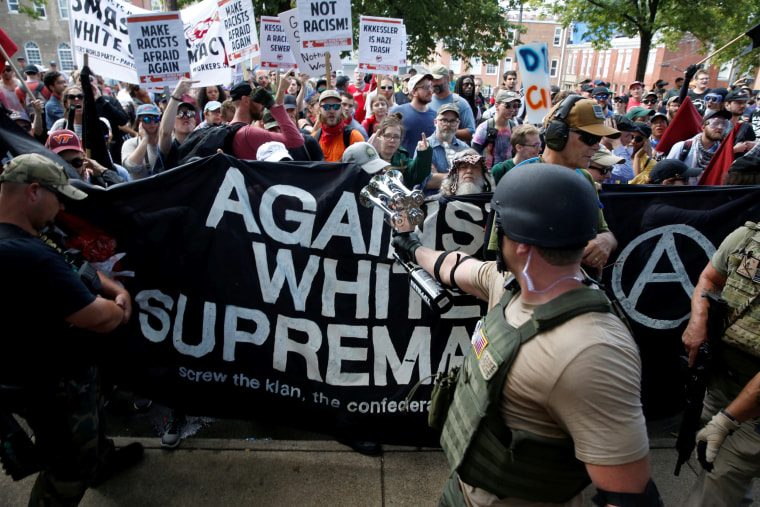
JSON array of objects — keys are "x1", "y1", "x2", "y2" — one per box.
[{"x1": 67, "y1": 154, "x2": 760, "y2": 445}]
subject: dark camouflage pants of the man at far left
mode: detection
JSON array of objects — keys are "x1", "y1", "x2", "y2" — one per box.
[{"x1": 21, "y1": 367, "x2": 113, "y2": 507}]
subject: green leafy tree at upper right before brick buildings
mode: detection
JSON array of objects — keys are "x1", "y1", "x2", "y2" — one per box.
[{"x1": 531, "y1": 0, "x2": 760, "y2": 81}]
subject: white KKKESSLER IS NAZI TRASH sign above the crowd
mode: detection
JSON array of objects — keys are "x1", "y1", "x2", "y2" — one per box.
[{"x1": 358, "y1": 16, "x2": 403, "y2": 74}]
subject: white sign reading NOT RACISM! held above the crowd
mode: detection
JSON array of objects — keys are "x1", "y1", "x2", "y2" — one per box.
[{"x1": 297, "y1": 0, "x2": 353, "y2": 52}]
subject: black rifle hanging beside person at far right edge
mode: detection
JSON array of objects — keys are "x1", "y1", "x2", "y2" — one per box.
[{"x1": 674, "y1": 292, "x2": 728, "y2": 475}]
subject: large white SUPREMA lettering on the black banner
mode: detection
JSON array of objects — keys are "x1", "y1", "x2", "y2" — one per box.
[{"x1": 135, "y1": 290, "x2": 470, "y2": 387}]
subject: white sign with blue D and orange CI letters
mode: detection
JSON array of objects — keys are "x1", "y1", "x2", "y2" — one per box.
[{"x1": 516, "y1": 42, "x2": 552, "y2": 123}]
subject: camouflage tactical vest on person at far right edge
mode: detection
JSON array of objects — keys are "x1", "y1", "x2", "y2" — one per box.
[{"x1": 722, "y1": 222, "x2": 760, "y2": 357}]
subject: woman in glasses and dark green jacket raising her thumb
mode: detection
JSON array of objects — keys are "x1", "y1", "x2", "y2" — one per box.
[{"x1": 369, "y1": 113, "x2": 433, "y2": 188}]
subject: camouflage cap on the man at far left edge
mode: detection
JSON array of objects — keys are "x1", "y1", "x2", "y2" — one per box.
[{"x1": 0, "y1": 153, "x2": 87, "y2": 201}]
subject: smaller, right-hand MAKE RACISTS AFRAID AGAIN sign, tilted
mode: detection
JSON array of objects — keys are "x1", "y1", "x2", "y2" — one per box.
[{"x1": 217, "y1": 0, "x2": 259, "y2": 66}]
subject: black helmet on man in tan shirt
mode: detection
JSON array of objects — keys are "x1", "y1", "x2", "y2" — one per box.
[{"x1": 491, "y1": 164, "x2": 599, "y2": 248}]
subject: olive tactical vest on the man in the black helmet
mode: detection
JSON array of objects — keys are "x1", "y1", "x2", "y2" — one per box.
[{"x1": 441, "y1": 281, "x2": 614, "y2": 502}]
